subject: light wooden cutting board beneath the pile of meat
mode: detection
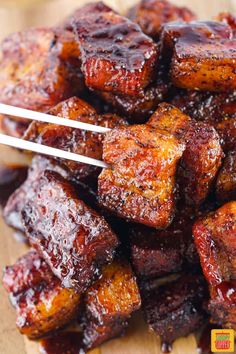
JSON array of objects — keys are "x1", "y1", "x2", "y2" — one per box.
[{"x1": 0, "y1": 0, "x2": 236, "y2": 354}]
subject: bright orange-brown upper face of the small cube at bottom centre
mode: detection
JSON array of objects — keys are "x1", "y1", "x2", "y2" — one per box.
[{"x1": 85, "y1": 259, "x2": 141, "y2": 325}]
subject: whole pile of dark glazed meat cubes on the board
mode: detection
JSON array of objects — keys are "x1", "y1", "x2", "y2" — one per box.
[{"x1": 0, "y1": 0, "x2": 236, "y2": 353}]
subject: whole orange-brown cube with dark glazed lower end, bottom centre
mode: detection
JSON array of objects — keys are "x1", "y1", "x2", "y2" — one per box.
[{"x1": 82, "y1": 258, "x2": 141, "y2": 348}]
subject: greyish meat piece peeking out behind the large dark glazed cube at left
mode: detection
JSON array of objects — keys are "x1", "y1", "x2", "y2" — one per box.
[{"x1": 3, "y1": 156, "x2": 69, "y2": 232}]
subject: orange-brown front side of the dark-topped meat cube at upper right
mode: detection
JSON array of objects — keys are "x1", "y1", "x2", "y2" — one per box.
[{"x1": 171, "y1": 39, "x2": 236, "y2": 92}]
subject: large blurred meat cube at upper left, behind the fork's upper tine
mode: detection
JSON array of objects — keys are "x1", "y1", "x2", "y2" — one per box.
[{"x1": 0, "y1": 28, "x2": 85, "y2": 137}]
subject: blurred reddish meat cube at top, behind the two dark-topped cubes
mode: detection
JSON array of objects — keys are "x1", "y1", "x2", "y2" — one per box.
[{"x1": 128, "y1": 0, "x2": 196, "y2": 40}]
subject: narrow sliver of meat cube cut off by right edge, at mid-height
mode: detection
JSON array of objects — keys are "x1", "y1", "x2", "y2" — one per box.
[{"x1": 216, "y1": 151, "x2": 236, "y2": 201}]
